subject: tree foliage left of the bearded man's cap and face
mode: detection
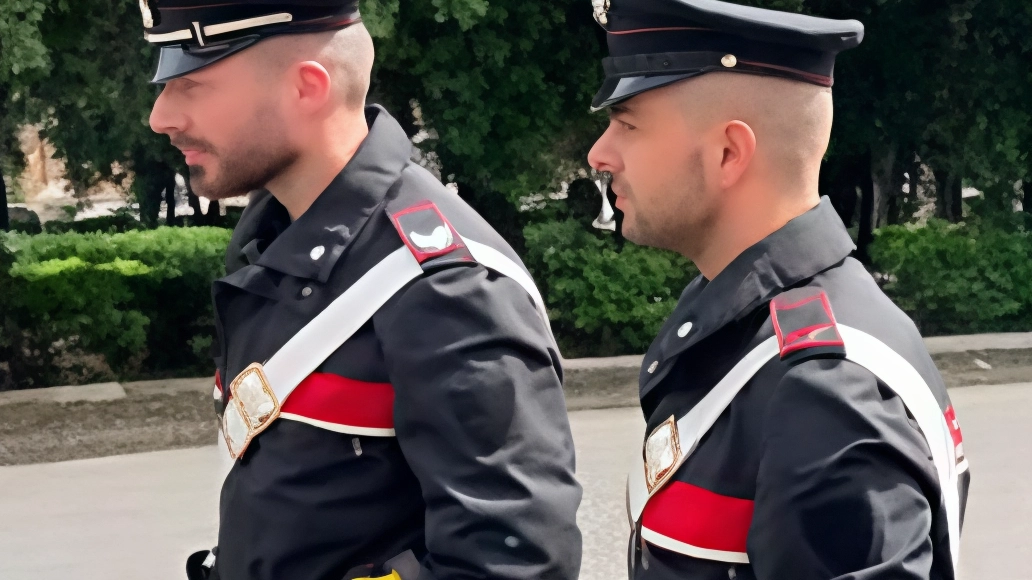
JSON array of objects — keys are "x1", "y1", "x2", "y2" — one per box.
[{"x1": 0, "y1": 0, "x2": 183, "y2": 224}]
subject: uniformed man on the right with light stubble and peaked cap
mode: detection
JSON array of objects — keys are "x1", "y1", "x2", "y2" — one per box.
[{"x1": 588, "y1": 0, "x2": 968, "y2": 580}]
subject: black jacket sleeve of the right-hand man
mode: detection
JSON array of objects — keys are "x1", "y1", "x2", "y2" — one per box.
[{"x1": 748, "y1": 360, "x2": 939, "y2": 580}]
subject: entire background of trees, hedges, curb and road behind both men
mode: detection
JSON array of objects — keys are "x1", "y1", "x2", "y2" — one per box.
[{"x1": 0, "y1": 0, "x2": 1032, "y2": 580}]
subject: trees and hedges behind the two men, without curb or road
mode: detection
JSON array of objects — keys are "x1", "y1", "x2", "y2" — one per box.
[{"x1": 0, "y1": 0, "x2": 1032, "y2": 390}]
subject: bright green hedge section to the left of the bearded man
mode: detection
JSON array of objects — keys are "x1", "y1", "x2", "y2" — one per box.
[{"x1": 0, "y1": 227, "x2": 230, "y2": 388}]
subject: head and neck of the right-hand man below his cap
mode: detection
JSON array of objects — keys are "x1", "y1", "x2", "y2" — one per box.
[{"x1": 588, "y1": 72, "x2": 833, "y2": 277}]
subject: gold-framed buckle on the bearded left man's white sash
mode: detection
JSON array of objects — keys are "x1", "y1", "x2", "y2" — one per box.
[{"x1": 222, "y1": 362, "x2": 280, "y2": 459}]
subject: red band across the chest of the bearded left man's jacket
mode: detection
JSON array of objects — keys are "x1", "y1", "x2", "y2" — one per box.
[{"x1": 282, "y1": 373, "x2": 394, "y2": 429}]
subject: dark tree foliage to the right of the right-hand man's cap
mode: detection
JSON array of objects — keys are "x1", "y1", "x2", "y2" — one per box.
[{"x1": 804, "y1": 0, "x2": 1032, "y2": 243}]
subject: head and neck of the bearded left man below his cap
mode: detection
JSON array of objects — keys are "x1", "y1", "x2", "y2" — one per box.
[{"x1": 151, "y1": 24, "x2": 374, "y2": 205}]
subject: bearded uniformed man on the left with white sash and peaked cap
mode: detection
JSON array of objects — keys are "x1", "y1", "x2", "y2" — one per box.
[{"x1": 140, "y1": 0, "x2": 581, "y2": 580}]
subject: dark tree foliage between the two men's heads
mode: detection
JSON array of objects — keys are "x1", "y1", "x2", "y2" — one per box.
[{"x1": 361, "y1": 0, "x2": 605, "y2": 247}]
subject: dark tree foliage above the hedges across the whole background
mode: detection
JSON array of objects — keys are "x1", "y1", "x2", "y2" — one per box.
[{"x1": 0, "y1": 0, "x2": 1032, "y2": 357}]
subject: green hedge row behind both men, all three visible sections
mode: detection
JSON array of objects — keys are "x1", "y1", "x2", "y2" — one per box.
[{"x1": 0, "y1": 220, "x2": 1032, "y2": 389}]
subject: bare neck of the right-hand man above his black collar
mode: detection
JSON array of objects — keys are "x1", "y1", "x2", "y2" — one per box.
[{"x1": 685, "y1": 182, "x2": 820, "y2": 280}]
